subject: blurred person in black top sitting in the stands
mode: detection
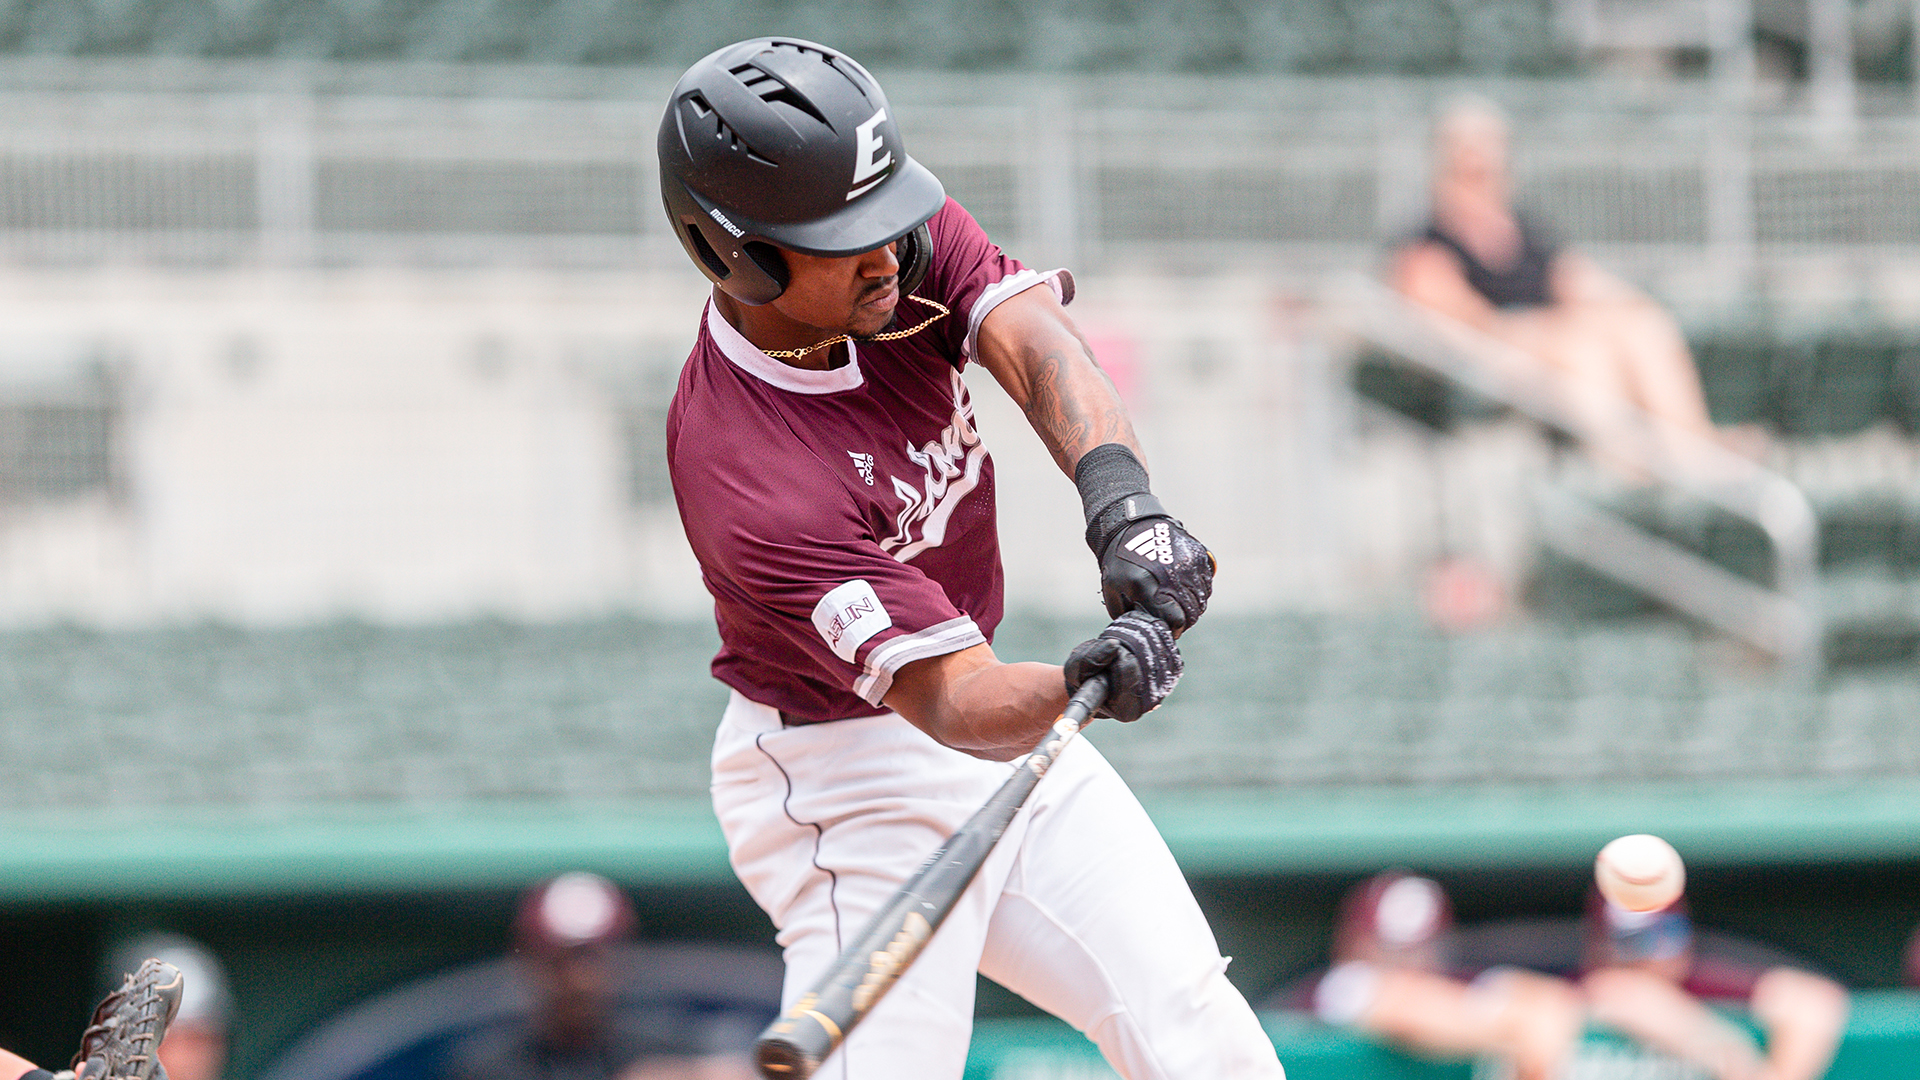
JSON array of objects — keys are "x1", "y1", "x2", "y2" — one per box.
[{"x1": 1392, "y1": 98, "x2": 1764, "y2": 475}]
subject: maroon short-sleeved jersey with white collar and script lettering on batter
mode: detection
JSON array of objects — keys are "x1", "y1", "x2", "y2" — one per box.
[{"x1": 666, "y1": 200, "x2": 1071, "y2": 721}]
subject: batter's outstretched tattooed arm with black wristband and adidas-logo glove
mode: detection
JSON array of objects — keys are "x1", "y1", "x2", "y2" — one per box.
[{"x1": 977, "y1": 284, "x2": 1213, "y2": 634}]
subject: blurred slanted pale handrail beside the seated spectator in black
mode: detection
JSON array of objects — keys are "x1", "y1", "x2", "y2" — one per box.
[{"x1": 1327, "y1": 275, "x2": 1822, "y2": 667}]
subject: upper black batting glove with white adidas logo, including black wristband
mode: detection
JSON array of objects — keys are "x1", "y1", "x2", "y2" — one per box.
[{"x1": 1073, "y1": 442, "x2": 1213, "y2": 636}]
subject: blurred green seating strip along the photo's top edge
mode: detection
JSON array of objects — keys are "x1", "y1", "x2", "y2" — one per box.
[{"x1": 0, "y1": 0, "x2": 1571, "y2": 73}]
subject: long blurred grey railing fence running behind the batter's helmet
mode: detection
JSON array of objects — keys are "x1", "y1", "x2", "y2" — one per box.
[{"x1": 0, "y1": 61, "x2": 1920, "y2": 279}]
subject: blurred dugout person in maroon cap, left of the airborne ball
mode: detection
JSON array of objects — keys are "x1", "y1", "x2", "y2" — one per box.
[{"x1": 1311, "y1": 871, "x2": 1582, "y2": 1080}]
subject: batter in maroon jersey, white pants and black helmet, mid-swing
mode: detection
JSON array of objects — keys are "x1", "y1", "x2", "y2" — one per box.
[{"x1": 659, "y1": 38, "x2": 1283, "y2": 1080}]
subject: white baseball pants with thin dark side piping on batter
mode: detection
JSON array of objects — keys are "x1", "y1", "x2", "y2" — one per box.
[{"x1": 712, "y1": 694, "x2": 1283, "y2": 1080}]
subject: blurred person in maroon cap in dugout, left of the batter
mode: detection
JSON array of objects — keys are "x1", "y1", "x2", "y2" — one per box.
[{"x1": 442, "y1": 872, "x2": 753, "y2": 1080}]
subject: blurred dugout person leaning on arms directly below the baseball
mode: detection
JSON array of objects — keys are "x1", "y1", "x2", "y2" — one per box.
[{"x1": 1580, "y1": 892, "x2": 1847, "y2": 1080}]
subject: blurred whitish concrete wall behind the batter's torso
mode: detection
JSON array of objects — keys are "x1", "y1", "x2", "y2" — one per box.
[{"x1": 0, "y1": 267, "x2": 1489, "y2": 625}]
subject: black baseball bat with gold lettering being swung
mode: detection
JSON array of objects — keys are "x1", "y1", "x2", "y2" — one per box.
[{"x1": 753, "y1": 675, "x2": 1108, "y2": 1080}]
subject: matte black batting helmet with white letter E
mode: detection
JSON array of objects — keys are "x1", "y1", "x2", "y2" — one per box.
[{"x1": 659, "y1": 38, "x2": 947, "y2": 304}]
